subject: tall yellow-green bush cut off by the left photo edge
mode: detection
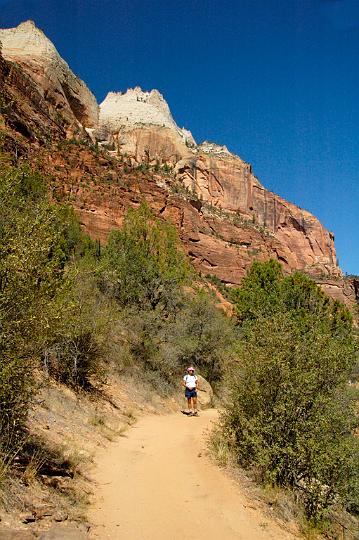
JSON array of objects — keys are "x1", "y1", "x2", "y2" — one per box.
[{"x1": 0, "y1": 166, "x2": 73, "y2": 448}]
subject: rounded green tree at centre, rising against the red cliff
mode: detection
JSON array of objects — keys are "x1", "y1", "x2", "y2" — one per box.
[{"x1": 102, "y1": 205, "x2": 191, "y2": 310}]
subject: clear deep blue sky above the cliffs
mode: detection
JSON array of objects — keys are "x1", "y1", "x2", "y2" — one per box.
[{"x1": 0, "y1": 0, "x2": 359, "y2": 274}]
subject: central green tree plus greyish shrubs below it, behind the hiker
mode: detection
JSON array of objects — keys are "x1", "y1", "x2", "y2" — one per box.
[{"x1": 97, "y1": 205, "x2": 233, "y2": 388}]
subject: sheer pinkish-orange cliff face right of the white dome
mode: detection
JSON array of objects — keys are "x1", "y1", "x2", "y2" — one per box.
[{"x1": 175, "y1": 152, "x2": 341, "y2": 276}]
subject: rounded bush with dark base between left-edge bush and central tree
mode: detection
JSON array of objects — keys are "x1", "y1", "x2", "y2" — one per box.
[{"x1": 42, "y1": 269, "x2": 114, "y2": 390}]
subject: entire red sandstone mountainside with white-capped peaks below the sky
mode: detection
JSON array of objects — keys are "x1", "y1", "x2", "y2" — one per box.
[{"x1": 0, "y1": 22, "x2": 358, "y2": 310}]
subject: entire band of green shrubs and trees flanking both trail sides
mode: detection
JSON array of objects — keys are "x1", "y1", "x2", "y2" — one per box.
[{"x1": 0, "y1": 150, "x2": 359, "y2": 532}]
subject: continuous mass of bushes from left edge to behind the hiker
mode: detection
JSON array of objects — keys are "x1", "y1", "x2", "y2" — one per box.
[{"x1": 0, "y1": 157, "x2": 232, "y2": 448}]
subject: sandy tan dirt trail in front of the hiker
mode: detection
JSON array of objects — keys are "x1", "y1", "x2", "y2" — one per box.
[{"x1": 90, "y1": 410, "x2": 294, "y2": 540}]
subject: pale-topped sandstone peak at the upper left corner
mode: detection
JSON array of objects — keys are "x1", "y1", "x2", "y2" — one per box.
[{"x1": 0, "y1": 21, "x2": 98, "y2": 131}]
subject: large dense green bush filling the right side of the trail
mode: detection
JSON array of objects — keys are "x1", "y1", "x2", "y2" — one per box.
[{"x1": 222, "y1": 261, "x2": 359, "y2": 519}]
